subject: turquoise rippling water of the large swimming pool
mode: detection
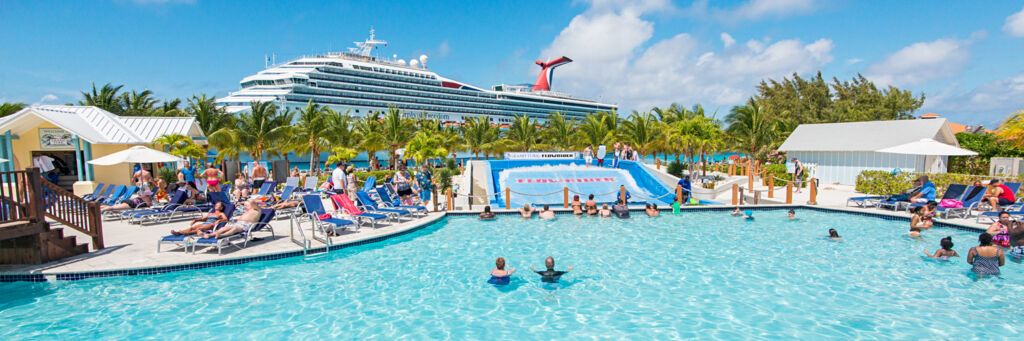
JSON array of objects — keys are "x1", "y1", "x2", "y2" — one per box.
[{"x1": 0, "y1": 210, "x2": 1024, "y2": 340}]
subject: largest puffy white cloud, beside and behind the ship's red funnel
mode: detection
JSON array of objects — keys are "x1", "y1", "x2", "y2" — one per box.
[{"x1": 532, "y1": 3, "x2": 834, "y2": 111}]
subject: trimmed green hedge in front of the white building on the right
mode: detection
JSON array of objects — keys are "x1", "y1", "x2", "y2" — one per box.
[{"x1": 855, "y1": 171, "x2": 1024, "y2": 198}]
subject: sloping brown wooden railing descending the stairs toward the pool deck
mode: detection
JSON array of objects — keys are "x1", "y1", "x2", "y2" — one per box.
[{"x1": 39, "y1": 177, "x2": 103, "y2": 250}]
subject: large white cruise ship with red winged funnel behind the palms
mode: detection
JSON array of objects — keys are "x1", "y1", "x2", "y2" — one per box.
[{"x1": 217, "y1": 30, "x2": 616, "y2": 126}]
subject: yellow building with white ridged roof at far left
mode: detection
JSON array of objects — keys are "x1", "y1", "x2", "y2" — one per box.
[{"x1": 0, "y1": 105, "x2": 205, "y2": 195}]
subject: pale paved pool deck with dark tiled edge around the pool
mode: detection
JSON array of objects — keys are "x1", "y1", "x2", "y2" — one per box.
[{"x1": 0, "y1": 163, "x2": 987, "y2": 282}]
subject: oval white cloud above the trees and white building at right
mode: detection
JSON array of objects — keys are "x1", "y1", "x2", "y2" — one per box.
[{"x1": 865, "y1": 39, "x2": 971, "y2": 86}]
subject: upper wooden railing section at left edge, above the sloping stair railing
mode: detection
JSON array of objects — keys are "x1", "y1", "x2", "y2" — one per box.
[{"x1": 0, "y1": 168, "x2": 43, "y2": 222}]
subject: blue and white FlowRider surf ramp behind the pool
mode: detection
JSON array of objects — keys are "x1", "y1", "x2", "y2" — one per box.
[{"x1": 487, "y1": 160, "x2": 673, "y2": 207}]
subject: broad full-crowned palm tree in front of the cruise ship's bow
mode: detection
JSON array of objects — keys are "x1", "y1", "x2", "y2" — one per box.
[{"x1": 210, "y1": 100, "x2": 295, "y2": 161}]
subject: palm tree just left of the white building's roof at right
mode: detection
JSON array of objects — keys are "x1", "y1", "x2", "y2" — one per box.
[{"x1": 725, "y1": 98, "x2": 776, "y2": 158}]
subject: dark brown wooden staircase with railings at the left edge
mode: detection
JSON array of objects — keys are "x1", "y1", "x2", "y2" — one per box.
[{"x1": 0, "y1": 168, "x2": 103, "y2": 264}]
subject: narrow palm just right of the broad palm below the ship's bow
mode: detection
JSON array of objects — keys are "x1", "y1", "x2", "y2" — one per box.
[{"x1": 289, "y1": 100, "x2": 337, "y2": 170}]
